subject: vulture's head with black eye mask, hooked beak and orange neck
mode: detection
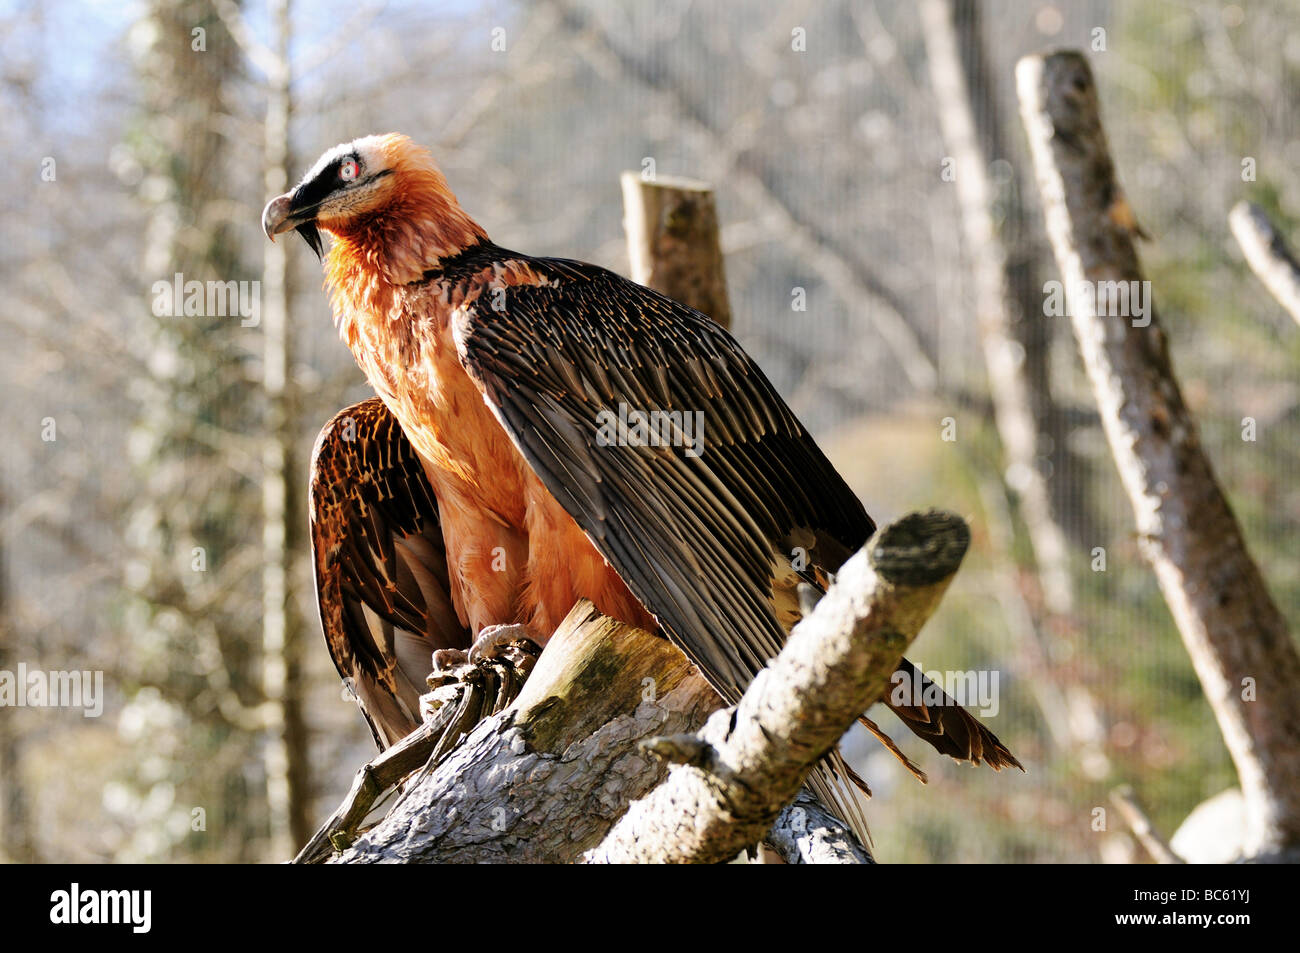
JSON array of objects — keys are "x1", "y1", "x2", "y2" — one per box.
[{"x1": 261, "y1": 133, "x2": 486, "y2": 280}]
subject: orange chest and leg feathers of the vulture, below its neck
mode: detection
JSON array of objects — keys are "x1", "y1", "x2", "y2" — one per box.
[{"x1": 335, "y1": 261, "x2": 654, "y2": 642}]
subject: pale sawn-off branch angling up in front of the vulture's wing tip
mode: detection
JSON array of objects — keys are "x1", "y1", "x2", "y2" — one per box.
[{"x1": 584, "y1": 512, "x2": 970, "y2": 863}]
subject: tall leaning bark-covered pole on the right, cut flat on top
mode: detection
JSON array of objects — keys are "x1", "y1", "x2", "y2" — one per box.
[{"x1": 1017, "y1": 51, "x2": 1300, "y2": 854}]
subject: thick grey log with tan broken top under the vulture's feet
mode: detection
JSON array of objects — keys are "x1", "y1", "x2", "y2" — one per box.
[{"x1": 335, "y1": 602, "x2": 722, "y2": 863}]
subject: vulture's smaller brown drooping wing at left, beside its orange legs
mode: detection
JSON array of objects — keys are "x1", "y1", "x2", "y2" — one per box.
[{"x1": 309, "y1": 398, "x2": 469, "y2": 748}]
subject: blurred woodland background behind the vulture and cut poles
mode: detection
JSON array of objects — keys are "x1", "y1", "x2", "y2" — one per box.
[{"x1": 0, "y1": 0, "x2": 1300, "y2": 862}]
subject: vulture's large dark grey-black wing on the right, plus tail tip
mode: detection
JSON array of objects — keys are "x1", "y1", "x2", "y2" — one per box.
[{"x1": 458, "y1": 252, "x2": 1017, "y2": 767}]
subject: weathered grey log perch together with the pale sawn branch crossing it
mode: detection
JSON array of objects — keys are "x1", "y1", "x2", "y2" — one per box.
[{"x1": 335, "y1": 514, "x2": 970, "y2": 863}]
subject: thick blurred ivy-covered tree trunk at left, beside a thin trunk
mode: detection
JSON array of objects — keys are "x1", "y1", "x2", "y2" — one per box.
[{"x1": 124, "y1": 0, "x2": 265, "y2": 861}]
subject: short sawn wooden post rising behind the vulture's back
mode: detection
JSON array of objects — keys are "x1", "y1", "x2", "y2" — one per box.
[{"x1": 623, "y1": 172, "x2": 731, "y2": 329}]
